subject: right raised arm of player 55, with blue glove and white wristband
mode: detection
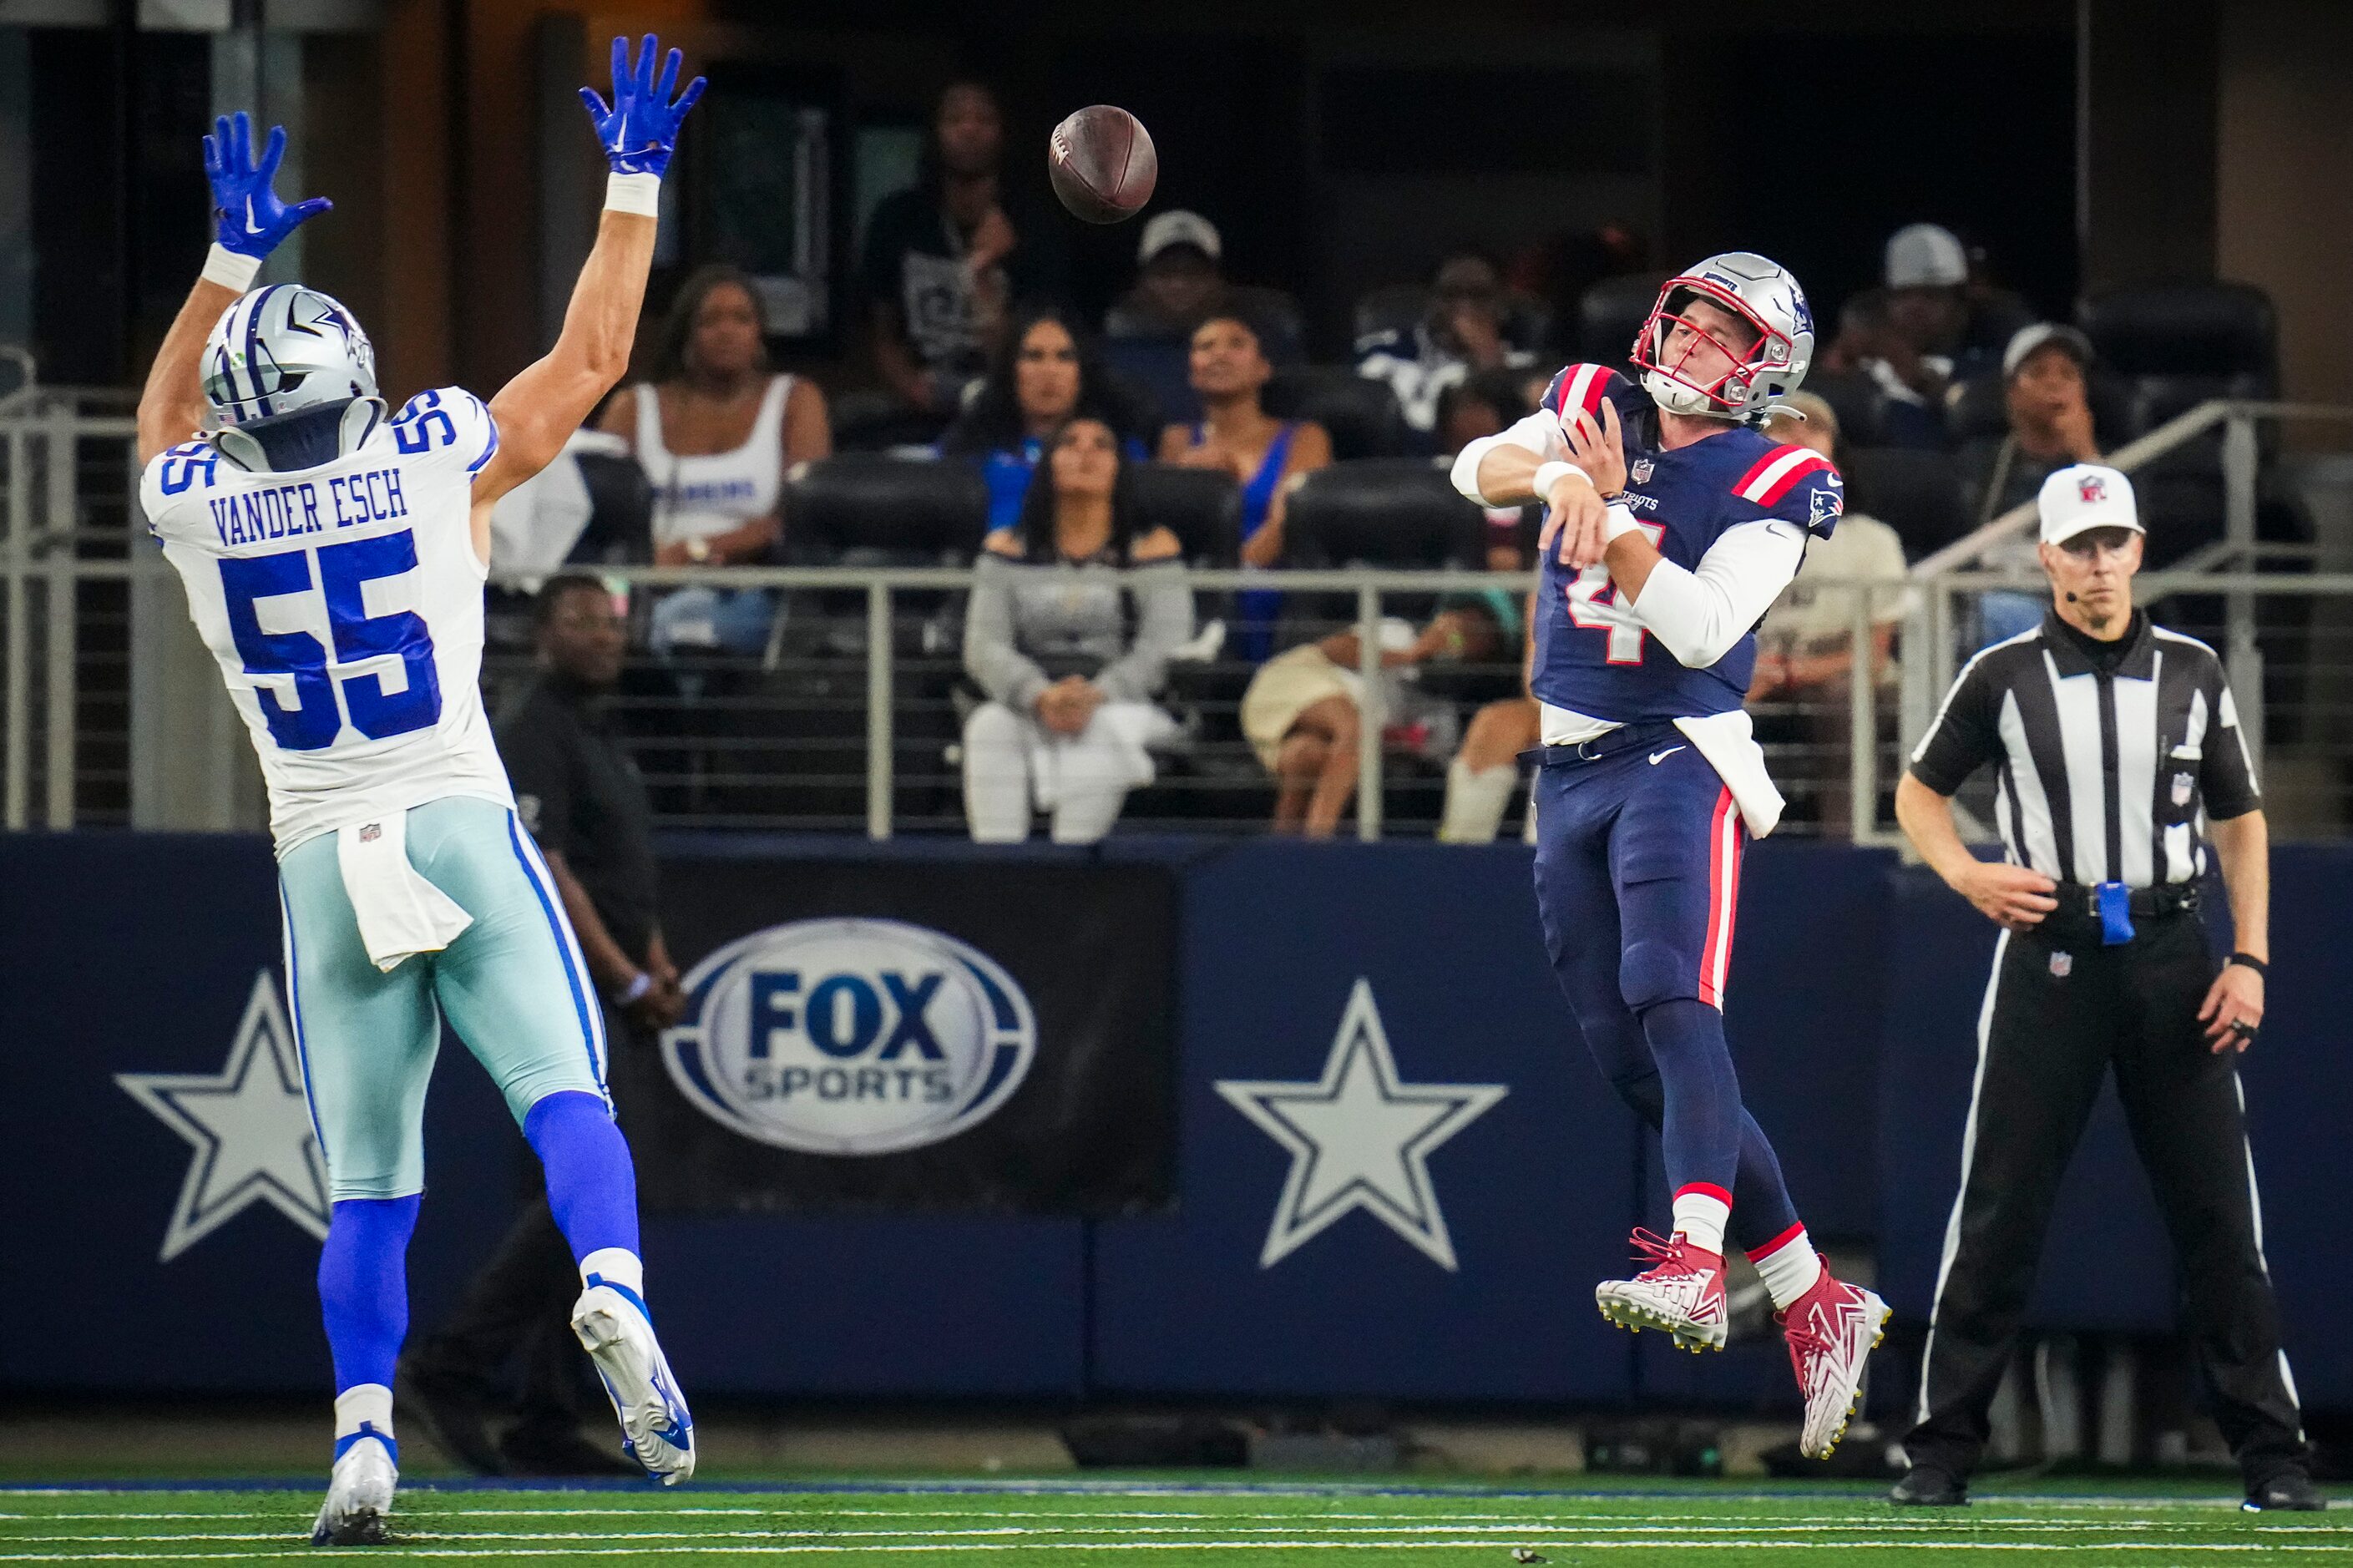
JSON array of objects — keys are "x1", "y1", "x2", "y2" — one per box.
[{"x1": 473, "y1": 33, "x2": 704, "y2": 518}]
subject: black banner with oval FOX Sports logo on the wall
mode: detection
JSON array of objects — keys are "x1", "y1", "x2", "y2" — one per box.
[{"x1": 612, "y1": 857, "x2": 1176, "y2": 1215}]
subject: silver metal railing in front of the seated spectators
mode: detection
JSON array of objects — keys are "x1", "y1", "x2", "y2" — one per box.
[{"x1": 13, "y1": 386, "x2": 2353, "y2": 841}]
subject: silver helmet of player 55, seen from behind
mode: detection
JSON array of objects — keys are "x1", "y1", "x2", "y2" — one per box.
[{"x1": 202, "y1": 282, "x2": 383, "y2": 471}]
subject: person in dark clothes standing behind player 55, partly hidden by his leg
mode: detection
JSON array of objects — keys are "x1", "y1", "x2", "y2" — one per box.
[{"x1": 400, "y1": 572, "x2": 685, "y2": 1476}]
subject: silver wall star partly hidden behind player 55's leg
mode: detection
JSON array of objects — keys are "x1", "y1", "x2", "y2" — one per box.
[{"x1": 115, "y1": 970, "x2": 327, "y2": 1262}]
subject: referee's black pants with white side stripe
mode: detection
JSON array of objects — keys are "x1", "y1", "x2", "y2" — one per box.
[{"x1": 1904, "y1": 916, "x2": 2304, "y2": 1488}]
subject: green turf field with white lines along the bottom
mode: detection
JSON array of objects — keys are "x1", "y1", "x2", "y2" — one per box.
[{"x1": 0, "y1": 1483, "x2": 2353, "y2": 1568}]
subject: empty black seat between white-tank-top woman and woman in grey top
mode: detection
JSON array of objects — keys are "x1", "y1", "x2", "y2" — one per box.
[{"x1": 783, "y1": 452, "x2": 989, "y2": 563}]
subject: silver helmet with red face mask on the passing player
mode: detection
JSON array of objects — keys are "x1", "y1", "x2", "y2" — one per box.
[{"x1": 1633, "y1": 250, "x2": 1814, "y2": 422}]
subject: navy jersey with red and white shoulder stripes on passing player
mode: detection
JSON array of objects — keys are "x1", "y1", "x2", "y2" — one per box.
[{"x1": 1513, "y1": 365, "x2": 1844, "y2": 723}]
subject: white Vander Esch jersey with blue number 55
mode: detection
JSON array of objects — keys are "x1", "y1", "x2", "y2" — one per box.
[{"x1": 139, "y1": 386, "x2": 513, "y2": 855}]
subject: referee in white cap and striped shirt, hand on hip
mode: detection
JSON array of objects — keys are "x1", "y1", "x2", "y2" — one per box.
[{"x1": 1894, "y1": 464, "x2": 2320, "y2": 1510}]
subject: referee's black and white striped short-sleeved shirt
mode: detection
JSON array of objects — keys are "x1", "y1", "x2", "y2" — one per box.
[{"x1": 1910, "y1": 609, "x2": 2261, "y2": 888}]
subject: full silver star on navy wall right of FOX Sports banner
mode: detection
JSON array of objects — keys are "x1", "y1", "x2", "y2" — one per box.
[{"x1": 1217, "y1": 979, "x2": 1508, "y2": 1269}]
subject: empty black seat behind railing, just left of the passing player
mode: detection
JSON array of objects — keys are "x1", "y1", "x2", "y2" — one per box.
[{"x1": 1283, "y1": 457, "x2": 1487, "y2": 568}]
